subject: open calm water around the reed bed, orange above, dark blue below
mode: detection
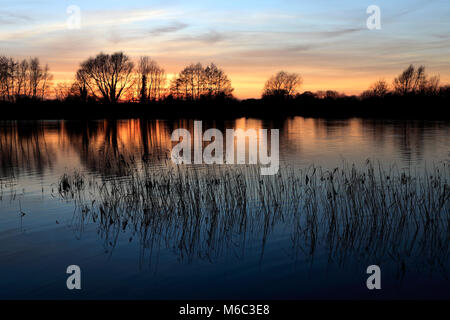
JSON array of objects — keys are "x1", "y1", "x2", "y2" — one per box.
[{"x1": 0, "y1": 117, "x2": 450, "y2": 299}]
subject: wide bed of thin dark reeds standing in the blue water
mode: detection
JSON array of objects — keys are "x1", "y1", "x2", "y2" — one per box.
[{"x1": 59, "y1": 158, "x2": 450, "y2": 275}]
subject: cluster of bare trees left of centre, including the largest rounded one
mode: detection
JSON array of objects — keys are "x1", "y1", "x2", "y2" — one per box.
[{"x1": 57, "y1": 52, "x2": 234, "y2": 103}]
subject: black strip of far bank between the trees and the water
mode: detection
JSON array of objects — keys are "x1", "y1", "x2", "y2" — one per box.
[{"x1": 0, "y1": 94, "x2": 450, "y2": 120}]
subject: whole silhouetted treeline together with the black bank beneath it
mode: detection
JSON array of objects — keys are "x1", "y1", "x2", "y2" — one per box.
[{"x1": 0, "y1": 52, "x2": 450, "y2": 122}]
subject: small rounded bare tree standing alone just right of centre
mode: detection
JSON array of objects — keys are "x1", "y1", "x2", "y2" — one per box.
[{"x1": 263, "y1": 71, "x2": 303, "y2": 98}]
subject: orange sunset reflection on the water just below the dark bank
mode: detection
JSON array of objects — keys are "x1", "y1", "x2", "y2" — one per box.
[{"x1": 0, "y1": 117, "x2": 450, "y2": 177}]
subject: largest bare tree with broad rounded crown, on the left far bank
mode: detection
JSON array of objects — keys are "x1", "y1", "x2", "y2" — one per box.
[{"x1": 78, "y1": 52, "x2": 134, "y2": 103}]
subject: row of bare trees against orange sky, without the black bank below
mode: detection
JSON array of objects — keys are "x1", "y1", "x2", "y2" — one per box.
[{"x1": 0, "y1": 52, "x2": 450, "y2": 104}]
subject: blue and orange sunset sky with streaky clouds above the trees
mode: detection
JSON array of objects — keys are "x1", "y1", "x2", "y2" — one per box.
[{"x1": 0, "y1": 0, "x2": 450, "y2": 98}]
